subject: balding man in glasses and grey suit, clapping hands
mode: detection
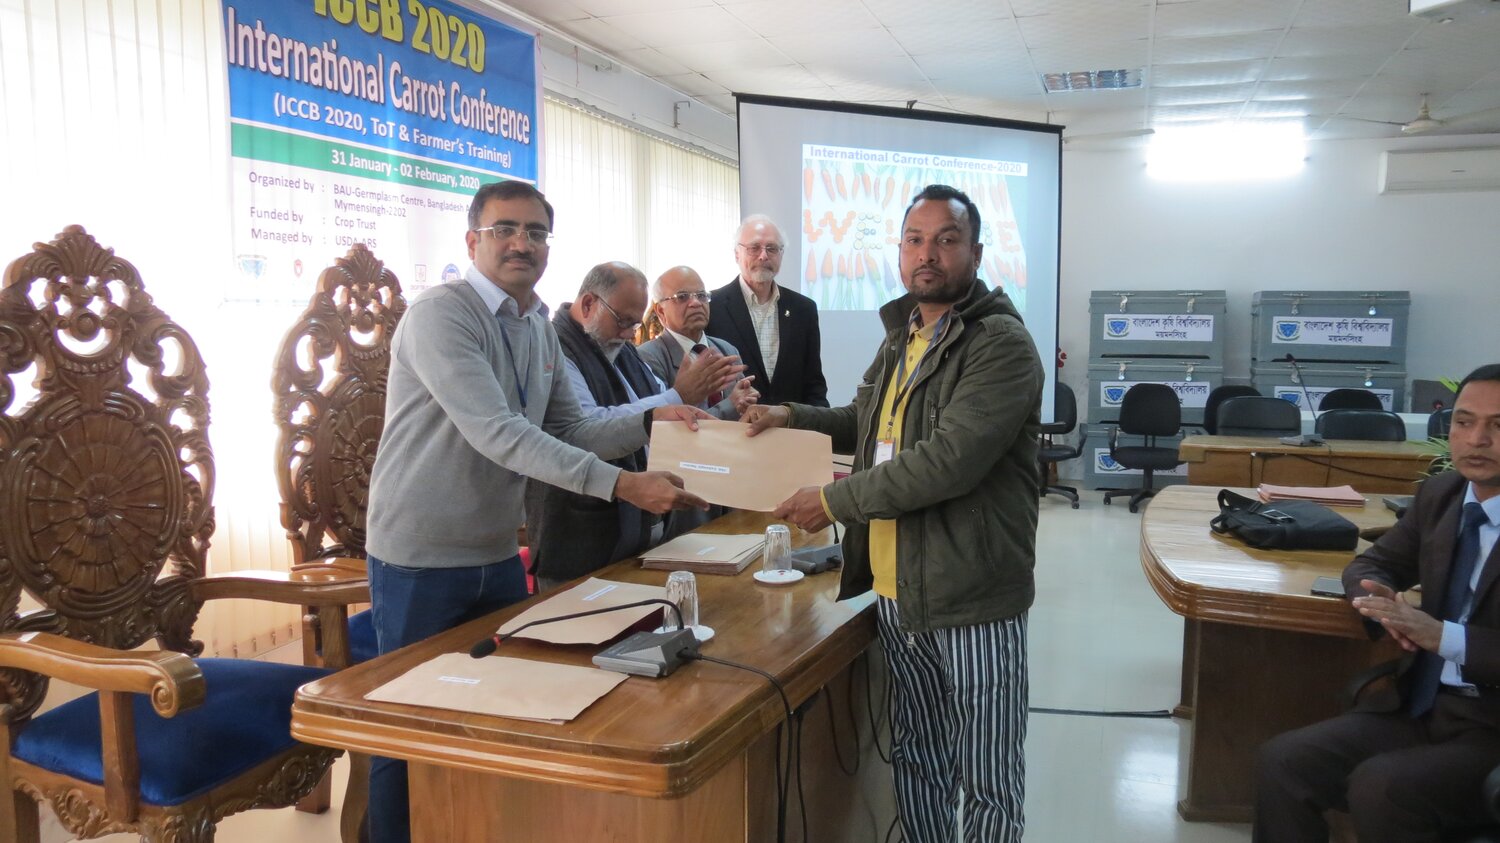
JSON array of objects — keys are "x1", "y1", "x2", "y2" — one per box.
[{"x1": 638, "y1": 267, "x2": 761, "y2": 422}]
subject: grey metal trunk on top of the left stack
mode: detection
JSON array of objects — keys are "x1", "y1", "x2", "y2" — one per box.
[{"x1": 1089, "y1": 290, "x2": 1224, "y2": 363}]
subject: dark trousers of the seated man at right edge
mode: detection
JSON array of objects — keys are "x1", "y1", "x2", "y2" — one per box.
[{"x1": 1254, "y1": 695, "x2": 1500, "y2": 843}]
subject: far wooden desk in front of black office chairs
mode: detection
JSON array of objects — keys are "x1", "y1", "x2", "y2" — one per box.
[{"x1": 1178, "y1": 437, "x2": 1433, "y2": 495}]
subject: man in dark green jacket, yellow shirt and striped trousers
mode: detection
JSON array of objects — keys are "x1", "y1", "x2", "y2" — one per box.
[{"x1": 744, "y1": 185, "x2": 1043, "y2": 843}]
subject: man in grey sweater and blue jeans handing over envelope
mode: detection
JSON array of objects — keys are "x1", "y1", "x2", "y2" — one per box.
[{"x1": 366, "y1": 182, "x2": 708, "y2": 843}]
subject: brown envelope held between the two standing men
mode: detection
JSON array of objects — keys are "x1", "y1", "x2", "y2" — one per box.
[{"x1": 647, "y1": 419, "x2": 834, "y2": 512}]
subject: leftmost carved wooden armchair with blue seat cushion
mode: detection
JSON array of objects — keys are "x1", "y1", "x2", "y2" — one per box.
[{"x1": 0, "y1": 227, "x2": 360, "y2": 843}]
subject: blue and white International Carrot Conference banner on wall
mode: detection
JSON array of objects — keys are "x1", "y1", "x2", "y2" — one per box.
[{"x1": 224, "y1": 0, "x2": 542, "y2": 302}]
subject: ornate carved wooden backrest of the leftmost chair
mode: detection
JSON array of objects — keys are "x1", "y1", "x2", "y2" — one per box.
[{"x1": 0, "y1": 225, "x2": 215, "y2": 722}]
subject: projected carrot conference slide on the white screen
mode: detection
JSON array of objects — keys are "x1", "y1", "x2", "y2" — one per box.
[{"x1": 804, "y1": 144, "x2": 1028, "y2": 312}]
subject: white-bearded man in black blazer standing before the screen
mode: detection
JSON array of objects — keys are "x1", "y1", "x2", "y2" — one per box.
[{"x1": 708, "y1": 215, "x2": 828, "y2": 407}]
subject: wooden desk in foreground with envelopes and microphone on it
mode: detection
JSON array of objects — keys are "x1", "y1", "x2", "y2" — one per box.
[{"x1": 291, "y1": 513, "x2": 894, "y2": 843}]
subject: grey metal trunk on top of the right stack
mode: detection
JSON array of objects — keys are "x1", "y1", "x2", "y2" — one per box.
[{"x1": 1250, "y1": 290, "x2": 1412, "y2": 361}]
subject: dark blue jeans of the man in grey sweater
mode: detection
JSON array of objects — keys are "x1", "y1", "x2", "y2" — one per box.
[{"x1": 368, "y1": 557, "x2": 527, "y2": 843}]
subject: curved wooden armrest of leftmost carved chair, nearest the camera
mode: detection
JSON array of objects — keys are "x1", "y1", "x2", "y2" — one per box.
[{"x1": 0, "y1": 632, "x2": 207, "y2": 717}]
